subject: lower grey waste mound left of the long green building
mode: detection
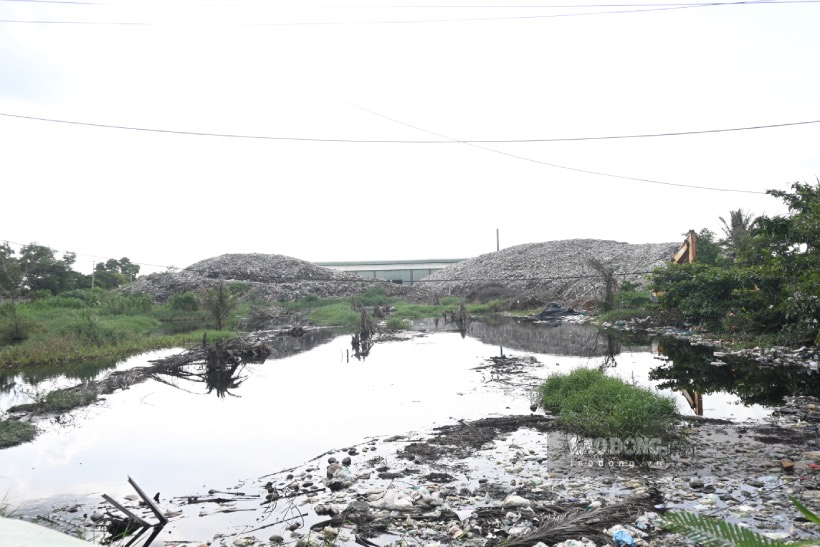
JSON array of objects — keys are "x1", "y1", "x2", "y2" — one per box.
[{"x1": 122, "y1": 253, "x2": 408, "y2": 302}]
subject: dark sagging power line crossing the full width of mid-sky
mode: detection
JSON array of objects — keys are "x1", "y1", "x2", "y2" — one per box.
[{"x1": 0, "y1": 111, "x2": 820, "y2": 144}]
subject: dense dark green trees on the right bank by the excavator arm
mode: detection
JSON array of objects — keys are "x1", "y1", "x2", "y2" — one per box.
[{"x1": 652, "y1": 180, "x2": 820, "y2": 344}]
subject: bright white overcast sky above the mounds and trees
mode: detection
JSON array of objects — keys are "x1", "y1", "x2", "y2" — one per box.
[{"x1": 0, "y1": 0, "x2": 820, "y2": 273}]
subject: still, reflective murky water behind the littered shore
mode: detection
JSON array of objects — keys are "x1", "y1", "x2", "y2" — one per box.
[{"x1": 0, "y1": 319, "x2": 818, "y2": 545}]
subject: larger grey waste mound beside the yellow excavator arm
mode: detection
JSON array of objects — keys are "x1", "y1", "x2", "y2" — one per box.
[{"x1": 418, "y1": 239, "x2": 680, "y2": 305}]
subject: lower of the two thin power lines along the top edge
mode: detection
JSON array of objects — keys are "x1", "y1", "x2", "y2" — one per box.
[{"x1": 0, "y1": 0, "x2": 820, "y2": 27}]
